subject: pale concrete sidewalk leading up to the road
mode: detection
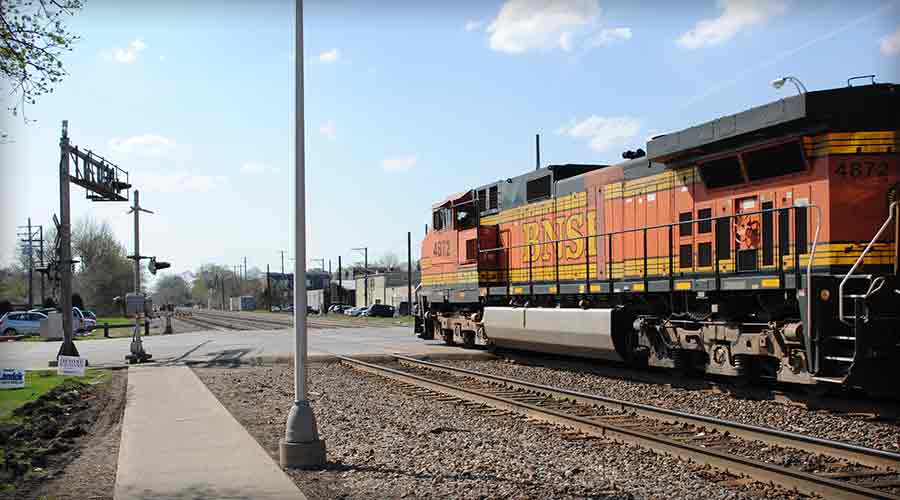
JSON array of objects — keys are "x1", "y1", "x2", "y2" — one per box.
[{"x1": 115, "y1": 366, "x2": 306, "y2": 500}]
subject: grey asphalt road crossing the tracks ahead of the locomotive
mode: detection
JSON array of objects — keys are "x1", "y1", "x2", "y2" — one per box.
[{"x1": 0, "y1": 327, "x2": 474, "y2": 370}]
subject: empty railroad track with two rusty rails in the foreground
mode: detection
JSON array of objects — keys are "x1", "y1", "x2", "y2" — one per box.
[{"x1": 340, "y1": 355, "x2": 900, "y2": 500}]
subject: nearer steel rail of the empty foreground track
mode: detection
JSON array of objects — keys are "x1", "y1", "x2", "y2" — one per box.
[{"x1": 338, "y1": 356, "x2": 900, "y2": 500}]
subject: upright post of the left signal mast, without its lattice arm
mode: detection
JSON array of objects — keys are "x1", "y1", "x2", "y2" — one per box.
[{"x1": 56, "y1": 120, "x2": 77, "y2": 358}]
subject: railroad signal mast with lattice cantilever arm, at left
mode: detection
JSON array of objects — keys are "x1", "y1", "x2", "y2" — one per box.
[{"x1": 56, "y1": 120, "x2": 130, "y2": 357}]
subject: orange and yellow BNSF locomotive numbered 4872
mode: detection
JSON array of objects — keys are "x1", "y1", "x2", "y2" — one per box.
[{"x1": 415, "y1": 84, "x2": 900, "y2": 396}]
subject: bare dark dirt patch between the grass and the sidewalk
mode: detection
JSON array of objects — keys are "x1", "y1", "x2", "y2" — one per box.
[{"x1": 0, "y1": 370, "x2": 127, "y2": 500}]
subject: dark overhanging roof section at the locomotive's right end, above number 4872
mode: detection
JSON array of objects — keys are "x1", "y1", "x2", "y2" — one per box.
[{"x1": 647, "y1": 83, "x2": 900, "y2": 162}]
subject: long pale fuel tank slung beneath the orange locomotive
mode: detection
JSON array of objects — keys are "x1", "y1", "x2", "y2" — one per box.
[{"x1": 483, "y1": 307, "x2": 622, "y2": 361}]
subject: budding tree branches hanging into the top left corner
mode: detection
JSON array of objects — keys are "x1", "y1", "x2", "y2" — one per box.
[{"x1": 0, "y1": 0, "x2": 83, "y2": 115}]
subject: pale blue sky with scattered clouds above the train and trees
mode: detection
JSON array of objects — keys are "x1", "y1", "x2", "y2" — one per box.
[{"x1": 0, "y1": 0, "x2": 900, "y2": 282}]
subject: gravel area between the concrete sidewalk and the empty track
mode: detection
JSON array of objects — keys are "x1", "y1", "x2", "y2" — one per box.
[{"x1": 195, "y1": 363, "x2": 801, "y2": 499}]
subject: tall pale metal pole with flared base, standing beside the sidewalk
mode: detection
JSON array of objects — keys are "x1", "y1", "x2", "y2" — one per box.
[{"x1": 278, "y1": 0, "x2": 325, "y2": 468}]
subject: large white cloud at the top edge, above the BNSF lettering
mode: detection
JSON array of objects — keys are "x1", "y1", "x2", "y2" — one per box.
[{"x1": 487, "y1": 0, "x2": 600, "y2": 54}]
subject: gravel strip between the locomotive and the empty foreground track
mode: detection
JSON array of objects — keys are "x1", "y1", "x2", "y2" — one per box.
[{"x1": 439, "y1": 360, "x2": 900, "y2": 451}]
